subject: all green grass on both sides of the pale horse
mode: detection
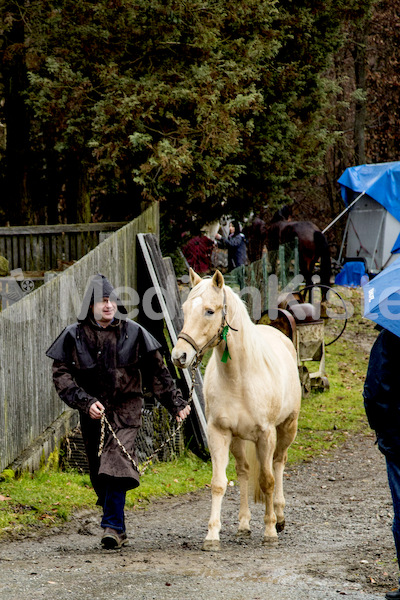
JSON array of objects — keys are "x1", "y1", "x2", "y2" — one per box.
[{"x1": 0, "y1": 290, "x2": 376, "y2": 535}]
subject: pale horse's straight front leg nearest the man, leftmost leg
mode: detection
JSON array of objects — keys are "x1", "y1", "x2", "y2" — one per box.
[{"x1": 203, "y1": 424, "x2": 232, "y2": 550}]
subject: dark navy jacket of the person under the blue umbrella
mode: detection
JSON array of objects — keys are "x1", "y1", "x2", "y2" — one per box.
[{"x1": 363, "y1": 329, "x2": 400, "y2": 465}]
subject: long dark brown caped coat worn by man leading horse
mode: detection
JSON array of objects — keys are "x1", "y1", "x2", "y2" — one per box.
[{"x1": 46, "y1": 317, "x2": 186, "y2": 494}]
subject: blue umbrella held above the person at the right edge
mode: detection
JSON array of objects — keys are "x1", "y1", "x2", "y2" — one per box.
[{"x1": 363, "y1": 258, "x2": 400, "y2": 337}]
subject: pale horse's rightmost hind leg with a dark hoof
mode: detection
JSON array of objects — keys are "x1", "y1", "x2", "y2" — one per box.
[{"x1": 274, "y1": 417, "x2": 297, "y2": 532}]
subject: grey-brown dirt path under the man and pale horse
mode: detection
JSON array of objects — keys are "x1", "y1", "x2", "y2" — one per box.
[{"x1": 0, "y1": 436, "x2": 397, "y2": 600}]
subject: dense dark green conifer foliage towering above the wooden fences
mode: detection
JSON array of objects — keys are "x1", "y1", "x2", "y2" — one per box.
[{"x1": 3, "y1": 0, "x2": 352, "y2": 225}]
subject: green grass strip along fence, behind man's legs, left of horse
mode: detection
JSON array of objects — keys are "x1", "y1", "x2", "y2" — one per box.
[{"x1": 0, "y1": 452, "x2": 235, "y2": 535}]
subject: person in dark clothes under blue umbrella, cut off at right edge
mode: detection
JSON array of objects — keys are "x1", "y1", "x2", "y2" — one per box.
[{"x1": 363, "y1": 329, "x2": 400, "y2": 600}]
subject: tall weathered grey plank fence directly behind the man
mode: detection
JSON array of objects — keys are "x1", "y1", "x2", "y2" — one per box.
[{"x1": 0, "y1": 205, "x2": 159, "y2": 471}]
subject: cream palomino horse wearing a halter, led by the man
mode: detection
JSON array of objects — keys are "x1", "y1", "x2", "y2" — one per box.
[{"x1": 172, "y1": 269, "x2": 301, "y2": 550}]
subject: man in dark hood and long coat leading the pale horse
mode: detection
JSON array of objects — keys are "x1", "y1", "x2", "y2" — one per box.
[{"x1": 46, "y1": 274, "x2": 190, "y2": 549}]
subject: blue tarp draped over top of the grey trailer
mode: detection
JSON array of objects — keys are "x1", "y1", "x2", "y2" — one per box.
[{"x1": 338, "y1": 161, "x2": 400, "y2": 221}]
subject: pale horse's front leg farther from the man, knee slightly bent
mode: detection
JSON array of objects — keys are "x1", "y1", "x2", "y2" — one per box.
[{"x1": 256, "y1": 426, "x2": 278, "y2": 544}]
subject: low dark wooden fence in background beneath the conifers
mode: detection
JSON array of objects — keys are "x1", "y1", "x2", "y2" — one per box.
[{"x1": 0, "y1": 222, "x2": 126, "y2": 271}]
